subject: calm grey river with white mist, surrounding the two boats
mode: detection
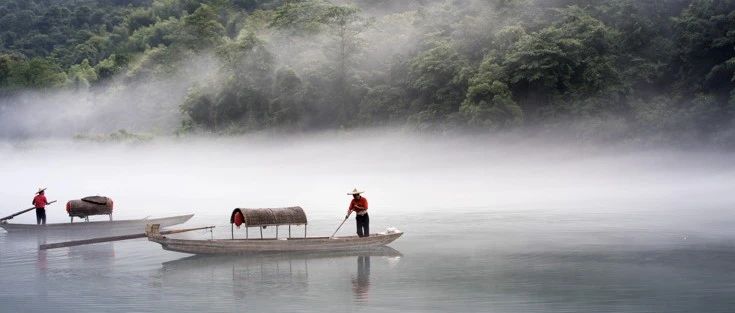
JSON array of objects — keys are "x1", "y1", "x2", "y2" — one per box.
[{"x1": 0, "y1": 133, "x2": 735, "y2": 312}]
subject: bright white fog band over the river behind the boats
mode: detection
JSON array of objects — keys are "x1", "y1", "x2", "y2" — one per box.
[{"x1": 0, "y1": 131, "x2": 735, "y2": 241}]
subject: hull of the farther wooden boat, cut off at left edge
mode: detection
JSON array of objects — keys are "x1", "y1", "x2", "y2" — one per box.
[{"x1": 0, "y1": 214, "x2": 194, "y2": 233}]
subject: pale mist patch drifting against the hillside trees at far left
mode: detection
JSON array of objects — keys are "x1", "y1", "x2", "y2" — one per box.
[{"x1": 0, "y1": 54, "x2": 217, "y2": 140}]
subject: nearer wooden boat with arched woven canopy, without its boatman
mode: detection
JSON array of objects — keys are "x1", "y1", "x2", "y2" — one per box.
[{"x1": 146, "y1": 207, "x2": 403, "y2": 254}]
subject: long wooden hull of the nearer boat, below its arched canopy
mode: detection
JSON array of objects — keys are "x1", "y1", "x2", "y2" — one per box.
[{"x1": 148, "y1": 232, "x2": 403, "y2": 254}]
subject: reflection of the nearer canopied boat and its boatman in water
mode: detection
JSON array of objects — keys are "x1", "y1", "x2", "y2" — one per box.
[{"x1": 160, "y1": 246, "x2": 402, "y2": 302}]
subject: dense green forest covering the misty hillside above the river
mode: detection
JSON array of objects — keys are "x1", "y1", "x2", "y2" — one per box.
[{"x1": 0, "y1": 0, "x2": 735, "y2": 145}]
